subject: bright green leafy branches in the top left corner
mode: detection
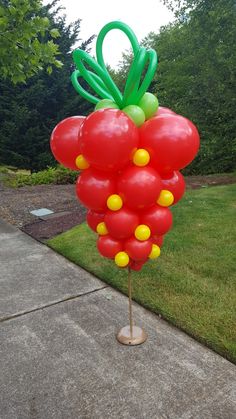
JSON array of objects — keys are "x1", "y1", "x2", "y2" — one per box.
[{"x1": 0, "y1": 0, "x2": 62, "y2": 83}]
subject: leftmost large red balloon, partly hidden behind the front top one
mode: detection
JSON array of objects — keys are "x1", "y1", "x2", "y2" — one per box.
[{"x1": 50, "y1": 116, "x2": 85, "y2": 170}]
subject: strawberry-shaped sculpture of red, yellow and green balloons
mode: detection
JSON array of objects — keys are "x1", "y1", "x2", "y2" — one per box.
[{"x1": 51, "y1": 22, "x2": 199, "y2": 344}]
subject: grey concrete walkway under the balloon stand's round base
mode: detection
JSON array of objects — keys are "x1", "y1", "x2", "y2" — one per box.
[{"x1": 0, "y1": 221, "x2": 236, "y2": 419}]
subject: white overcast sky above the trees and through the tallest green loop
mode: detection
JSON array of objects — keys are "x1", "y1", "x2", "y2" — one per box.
[{"x1": 43, "y1": 0, "x2": 173, "y2": 67}]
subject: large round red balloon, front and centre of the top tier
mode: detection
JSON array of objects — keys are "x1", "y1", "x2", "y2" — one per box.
[{"x1": 79, "y1": 109, "x2": 139, "y2": 171}]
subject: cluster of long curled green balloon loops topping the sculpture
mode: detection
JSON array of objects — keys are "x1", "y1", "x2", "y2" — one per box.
[{"x1": 71, "y1": 21, "x2": 157, "y2": 109}]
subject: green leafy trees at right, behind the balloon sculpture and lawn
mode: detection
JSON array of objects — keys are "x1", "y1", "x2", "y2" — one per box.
[{"x1": 120, "y1": 0, "x2": 236, "y2": 173}]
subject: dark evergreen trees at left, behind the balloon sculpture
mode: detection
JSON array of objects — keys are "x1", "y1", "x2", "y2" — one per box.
[{"x1": 0, "y1": 1, "x2": 92, "y2": 171}]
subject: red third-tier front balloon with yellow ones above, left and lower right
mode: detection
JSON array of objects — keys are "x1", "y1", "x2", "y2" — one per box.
[{"x1": 105, "y1": 207, "x2": 140, "y2": 239}]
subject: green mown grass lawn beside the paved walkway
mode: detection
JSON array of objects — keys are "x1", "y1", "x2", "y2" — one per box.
[{"x1": 48, "y1": 185, "x2": 236, "y2": 361}]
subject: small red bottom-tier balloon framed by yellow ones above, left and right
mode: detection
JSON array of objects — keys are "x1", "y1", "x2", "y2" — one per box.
[{"x1": 124, "y1": 237, "x2": 152, "y2": 261}]
